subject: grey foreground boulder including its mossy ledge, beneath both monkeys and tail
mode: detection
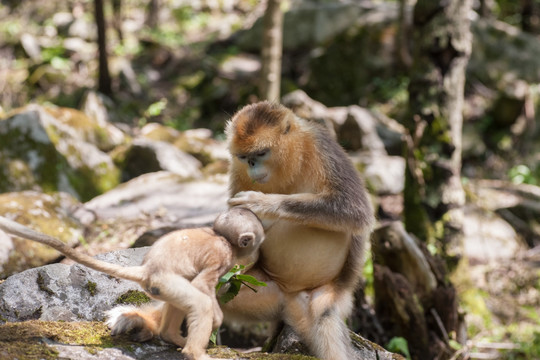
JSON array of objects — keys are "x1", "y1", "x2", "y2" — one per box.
[{"x1": 0, "y1": 248, "x2": 402, "y2": 360}]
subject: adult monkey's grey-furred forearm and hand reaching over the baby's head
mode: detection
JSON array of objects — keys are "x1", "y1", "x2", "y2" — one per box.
[{"x1": 229, "y1": 191, "x2": 373, "y2": 233}]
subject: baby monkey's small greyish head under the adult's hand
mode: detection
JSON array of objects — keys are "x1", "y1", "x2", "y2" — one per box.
[{"x1": 213, "y1": 207, "x2": 264, "y2": 251}]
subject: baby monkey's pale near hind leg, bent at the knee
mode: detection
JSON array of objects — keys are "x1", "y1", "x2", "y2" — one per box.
[{"x1": 150, "y1": 273, "x2": 213, "y2": 360}]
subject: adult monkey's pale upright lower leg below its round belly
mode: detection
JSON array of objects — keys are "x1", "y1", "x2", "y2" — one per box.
[{"x1": 285, "y1": 285, "x2": 355, "y2": 360}]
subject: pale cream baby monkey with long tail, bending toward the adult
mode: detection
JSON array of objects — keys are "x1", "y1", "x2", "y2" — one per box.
[{"x1": 0, "y1": 207, "x2": 264, "y2": 360}]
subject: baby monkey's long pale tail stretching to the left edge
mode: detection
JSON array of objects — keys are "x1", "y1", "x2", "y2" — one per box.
[{"x1": 0, "y1": 216, "x2": 144, "y2": 283}]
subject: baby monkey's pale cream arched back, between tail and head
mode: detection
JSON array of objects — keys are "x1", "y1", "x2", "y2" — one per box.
[{"x1": 143, "y1": 228, "x2": 233, "y2": 280}]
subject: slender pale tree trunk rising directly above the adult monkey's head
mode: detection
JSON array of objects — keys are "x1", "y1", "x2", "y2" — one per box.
[{"x1": 259, "y1": 0, "x2": 283, "y2": 101}]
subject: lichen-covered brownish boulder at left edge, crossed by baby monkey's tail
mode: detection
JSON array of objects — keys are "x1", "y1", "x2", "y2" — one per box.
[{"x1": 0, "y1": 191, "x2": 83, "y2": 278}]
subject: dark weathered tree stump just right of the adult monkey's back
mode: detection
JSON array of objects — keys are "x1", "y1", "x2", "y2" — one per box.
[{"x1": 371, "y1": 221, "x2": 465, "y2": 360}]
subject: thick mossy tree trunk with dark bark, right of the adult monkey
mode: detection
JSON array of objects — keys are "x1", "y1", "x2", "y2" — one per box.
[{"x1": 404, "y1": 0, "x2": 472, "y2": 261}]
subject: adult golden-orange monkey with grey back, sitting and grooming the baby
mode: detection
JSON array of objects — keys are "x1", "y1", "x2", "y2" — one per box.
[{"x1": 106, "y1": 102, "x2": 374, "y2": 360}]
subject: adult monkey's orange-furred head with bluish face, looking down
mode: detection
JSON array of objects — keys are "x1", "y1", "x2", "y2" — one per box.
[{"x1": 226, "y1": 101, "x2": 299, "y2": 184}]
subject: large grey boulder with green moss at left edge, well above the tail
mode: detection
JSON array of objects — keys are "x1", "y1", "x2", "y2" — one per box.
[{"x1": 0, "y1": 105, "x2": 120, "y2": 200}]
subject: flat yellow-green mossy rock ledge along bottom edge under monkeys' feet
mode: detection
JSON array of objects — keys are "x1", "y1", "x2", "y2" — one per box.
[{"x1": 0, "y1": 320, "x2": 315, "y2": 360}]
